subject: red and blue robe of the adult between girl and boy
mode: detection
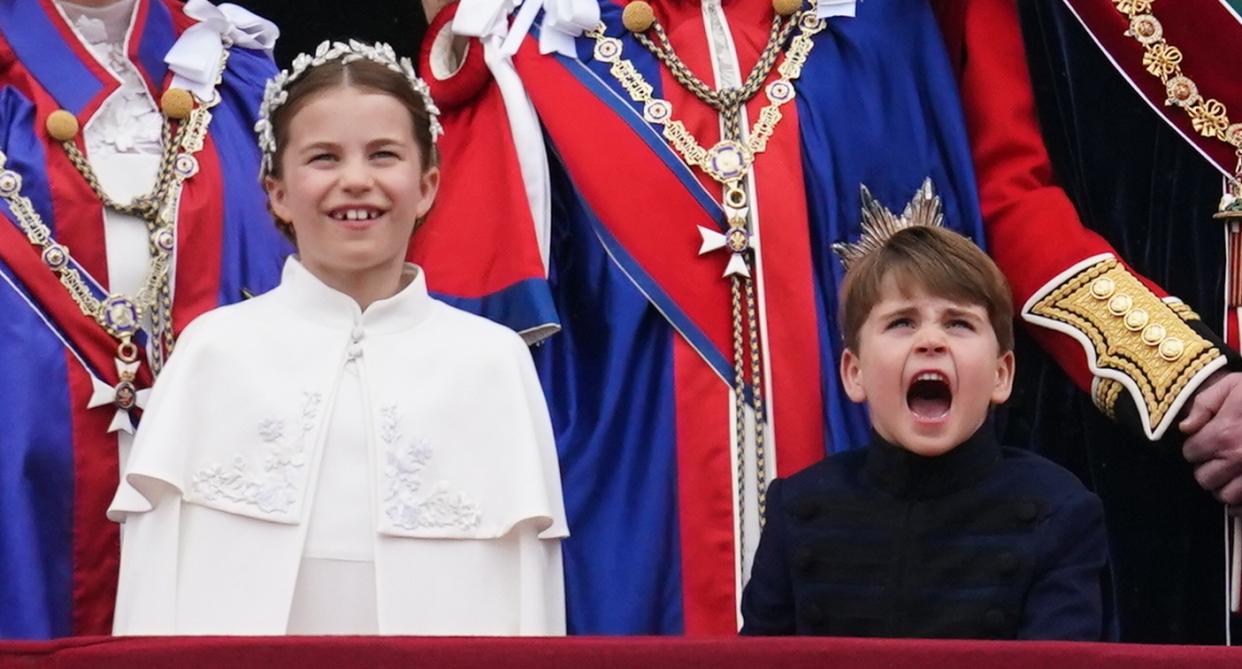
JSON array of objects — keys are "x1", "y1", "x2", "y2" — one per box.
[{"x1": 422, "y1": 0, "x2": 982, "y2": 634}]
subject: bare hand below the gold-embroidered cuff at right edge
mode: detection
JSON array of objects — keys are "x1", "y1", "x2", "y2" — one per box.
[{"x1": 1177, "y1": 372, "x2": 1242, "y2": 504}]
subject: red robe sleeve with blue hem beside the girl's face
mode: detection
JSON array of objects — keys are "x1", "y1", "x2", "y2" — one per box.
[{"x1": 407, "y1": 2, "x2": 558, "y2": 341}]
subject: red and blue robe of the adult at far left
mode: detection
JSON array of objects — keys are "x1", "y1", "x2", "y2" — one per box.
[{"x1": 0, "y1": 0, "x2": 289, "y2": 639}]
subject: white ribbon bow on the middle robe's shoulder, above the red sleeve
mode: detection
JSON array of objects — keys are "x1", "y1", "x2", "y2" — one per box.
[{"x1": 453, "y1": 0, "x2": 600, "y2": 58}]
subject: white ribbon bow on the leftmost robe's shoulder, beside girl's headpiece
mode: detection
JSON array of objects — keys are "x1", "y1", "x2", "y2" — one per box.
[{"x1": 164, "y1": 0, "x2": 281, "y2": 101}]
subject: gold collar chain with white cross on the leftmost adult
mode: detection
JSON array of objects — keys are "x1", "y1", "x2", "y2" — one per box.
[{"x1": 0, "y1": 52, "x2": 227, "y2": 432}]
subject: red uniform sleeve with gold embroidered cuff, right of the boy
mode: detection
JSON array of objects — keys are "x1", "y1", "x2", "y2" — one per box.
[{"x1": 936, "y1": 0, "x2": 1225, "y2": 438}]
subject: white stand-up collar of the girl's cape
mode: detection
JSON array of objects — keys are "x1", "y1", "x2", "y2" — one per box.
[{"x1": 276, "y1": 256, "x2": 436, "y2": 334}]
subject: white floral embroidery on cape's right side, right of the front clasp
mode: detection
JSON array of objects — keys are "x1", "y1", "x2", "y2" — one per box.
[{"x1": 380, "y1": 406, "x2": 483, "y2": 530}]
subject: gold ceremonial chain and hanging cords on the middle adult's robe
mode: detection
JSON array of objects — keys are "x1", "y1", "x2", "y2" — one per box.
[{"x1": 586, "y1": 0, "x2": 826, "y2": 545}]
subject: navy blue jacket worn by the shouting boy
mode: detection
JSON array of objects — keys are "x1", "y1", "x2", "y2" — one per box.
[{"x1": 741, "y1": 423, "x2": 1112, "y2": 640}]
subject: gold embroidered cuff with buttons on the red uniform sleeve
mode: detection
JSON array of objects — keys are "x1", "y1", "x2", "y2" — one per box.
[{"x1": 1030, "y1": 258, "x2": 1221, "y2": 427}]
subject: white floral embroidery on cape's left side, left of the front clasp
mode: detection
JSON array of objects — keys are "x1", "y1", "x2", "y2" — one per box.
[{"x1": 191, "y1": 392, "x2": 322, "y2": 514}]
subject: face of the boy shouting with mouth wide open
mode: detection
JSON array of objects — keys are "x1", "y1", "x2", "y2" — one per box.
[{"x1": 841, "y1": 277, "x2": 1013, "y2": 456}]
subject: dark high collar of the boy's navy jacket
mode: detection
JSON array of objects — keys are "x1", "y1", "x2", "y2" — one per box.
[{"x1": 866, "y1": 420, "x2": 1001, "y2": 499}]
